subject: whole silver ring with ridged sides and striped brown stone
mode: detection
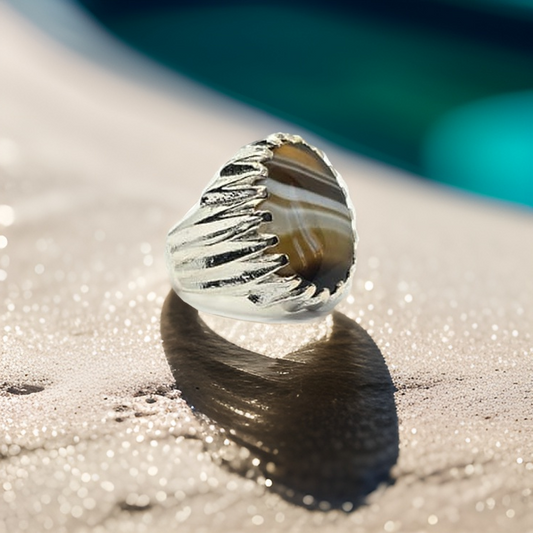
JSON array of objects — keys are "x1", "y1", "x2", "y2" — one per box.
[{"x1": 166, "y1": 133, "x2": 357, "y2": 322}]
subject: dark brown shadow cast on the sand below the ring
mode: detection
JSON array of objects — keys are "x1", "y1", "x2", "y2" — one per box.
[{"x1": 161, "y1": 291, "x2": 399, "y2": 511}]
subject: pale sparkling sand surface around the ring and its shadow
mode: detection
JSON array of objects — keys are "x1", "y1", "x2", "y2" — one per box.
[{"x1": 0, "y1": 5, "x2": 533, "y2": 533}]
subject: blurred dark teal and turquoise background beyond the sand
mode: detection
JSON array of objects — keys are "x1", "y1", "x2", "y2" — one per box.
[{"x1": 8, "y1": 0, "x2": 533, "y2": 206}]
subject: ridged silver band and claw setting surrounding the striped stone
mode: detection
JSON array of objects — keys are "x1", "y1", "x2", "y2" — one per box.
[{"x1": 166, "y1": 133, "x2": 357, "y2": 322}]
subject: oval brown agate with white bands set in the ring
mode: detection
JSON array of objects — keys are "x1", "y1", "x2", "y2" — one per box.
[{"x1": 258, "y1": 143, "x2": 355, "y2": 293}]
